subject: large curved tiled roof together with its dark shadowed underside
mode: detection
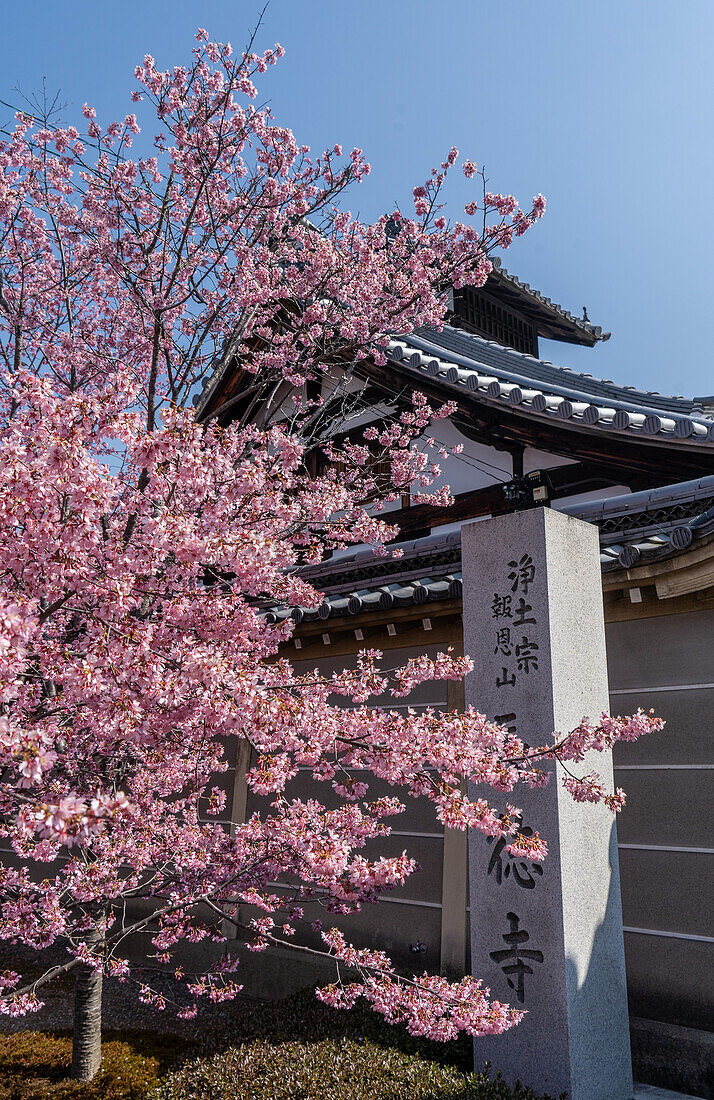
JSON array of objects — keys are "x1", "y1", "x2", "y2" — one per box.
[{"x1": 359, "y1": 327, "x2": 714, "y2": 485}]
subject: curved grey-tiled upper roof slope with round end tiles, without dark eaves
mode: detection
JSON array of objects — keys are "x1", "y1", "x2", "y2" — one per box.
[{"x1": 388, "y1": 326, "x2": 714, "y2": 446}]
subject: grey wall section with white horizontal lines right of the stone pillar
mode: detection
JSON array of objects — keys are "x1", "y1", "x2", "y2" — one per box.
[{"x1": 607, "y1": 611, "x2": 714, "y2": 1029}]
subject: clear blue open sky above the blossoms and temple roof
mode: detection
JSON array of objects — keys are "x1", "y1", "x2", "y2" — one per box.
[{"x1": 0, "y1": 0, "x2": 714, "y2": 396}]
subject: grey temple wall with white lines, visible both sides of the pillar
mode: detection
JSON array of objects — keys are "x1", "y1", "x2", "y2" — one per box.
[{"x1": 232, "y1": 600, "x2": 714, "y2": 1073}]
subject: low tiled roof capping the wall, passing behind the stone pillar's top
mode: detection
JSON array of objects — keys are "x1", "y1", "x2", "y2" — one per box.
[{"x1": 267, "y1": 475, "x2": 714, "y2": 623}]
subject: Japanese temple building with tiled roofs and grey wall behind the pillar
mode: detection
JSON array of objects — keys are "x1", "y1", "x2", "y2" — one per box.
[{"x1": 197, "y1": 266, "x2": 714, "y2": 1097}]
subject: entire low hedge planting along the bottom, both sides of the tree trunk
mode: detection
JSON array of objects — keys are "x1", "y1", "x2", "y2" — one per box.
[{"x1": 0, "y1": 989, "x2": 556, "y2": 1100}]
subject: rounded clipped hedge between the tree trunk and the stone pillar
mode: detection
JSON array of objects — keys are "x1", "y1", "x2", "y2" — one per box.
[{"x1": 152, "y1": 989, "x2": 556, "y2": 1100}]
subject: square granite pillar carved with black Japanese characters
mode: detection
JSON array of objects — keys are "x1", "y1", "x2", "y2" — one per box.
[{"x1": 462, "y1": 508, "x2": 633, "y2": 1100}]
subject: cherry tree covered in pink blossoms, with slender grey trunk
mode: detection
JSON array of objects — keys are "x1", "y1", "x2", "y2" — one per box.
[{"x1": 0, "y1": 31, "x2": 658, "y2": 1079}]
